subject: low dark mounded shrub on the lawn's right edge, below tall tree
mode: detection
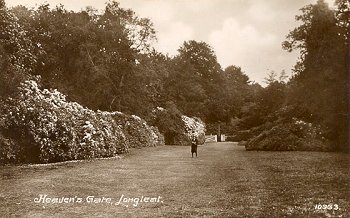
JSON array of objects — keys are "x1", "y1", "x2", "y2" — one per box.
[{"x1": 245, "y1": 118, "x2": 330, "y2": 151}]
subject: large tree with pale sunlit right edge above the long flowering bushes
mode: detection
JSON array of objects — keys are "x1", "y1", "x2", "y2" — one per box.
[{"x1": 13, "y1": 1, "x2": 155, "y2": 113}]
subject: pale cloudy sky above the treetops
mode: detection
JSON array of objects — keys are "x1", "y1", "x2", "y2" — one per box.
[{"x1": 5, "y1": 0, "x2": 334, "y2": 83}]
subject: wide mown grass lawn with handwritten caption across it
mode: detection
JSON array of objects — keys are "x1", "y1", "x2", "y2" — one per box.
[{"x1": 0, "y1": 143, "x2": 350, "y2": 217}]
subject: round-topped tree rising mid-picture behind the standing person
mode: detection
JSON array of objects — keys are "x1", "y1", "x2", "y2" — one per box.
[{"x1": 169, "y1": 40, "x2": 227, "y2": 122}]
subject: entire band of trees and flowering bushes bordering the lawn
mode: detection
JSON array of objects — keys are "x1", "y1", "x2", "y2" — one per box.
[{"x1": 0, "y1": 0, "x2": 350, "y2": 158}]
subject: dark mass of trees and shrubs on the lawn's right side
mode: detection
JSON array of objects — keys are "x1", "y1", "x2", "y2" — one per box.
[{"x1": 241, "y1": 0, "x2": 349, "y2": 150}]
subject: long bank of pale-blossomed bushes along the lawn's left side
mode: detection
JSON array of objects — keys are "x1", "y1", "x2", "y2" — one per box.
[{"x1": 0, "y1": 80, "x2": 162, "y2": 163}]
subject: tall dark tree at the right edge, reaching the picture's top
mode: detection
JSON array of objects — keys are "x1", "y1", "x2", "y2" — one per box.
[{"x1": 283, "y1": 0, "x2": 349, "y2": 148}]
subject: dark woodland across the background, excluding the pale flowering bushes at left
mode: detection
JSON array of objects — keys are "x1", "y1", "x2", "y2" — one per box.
[{"x1": 0, "y1": 0, "x2": 350, "y2": 160}]
